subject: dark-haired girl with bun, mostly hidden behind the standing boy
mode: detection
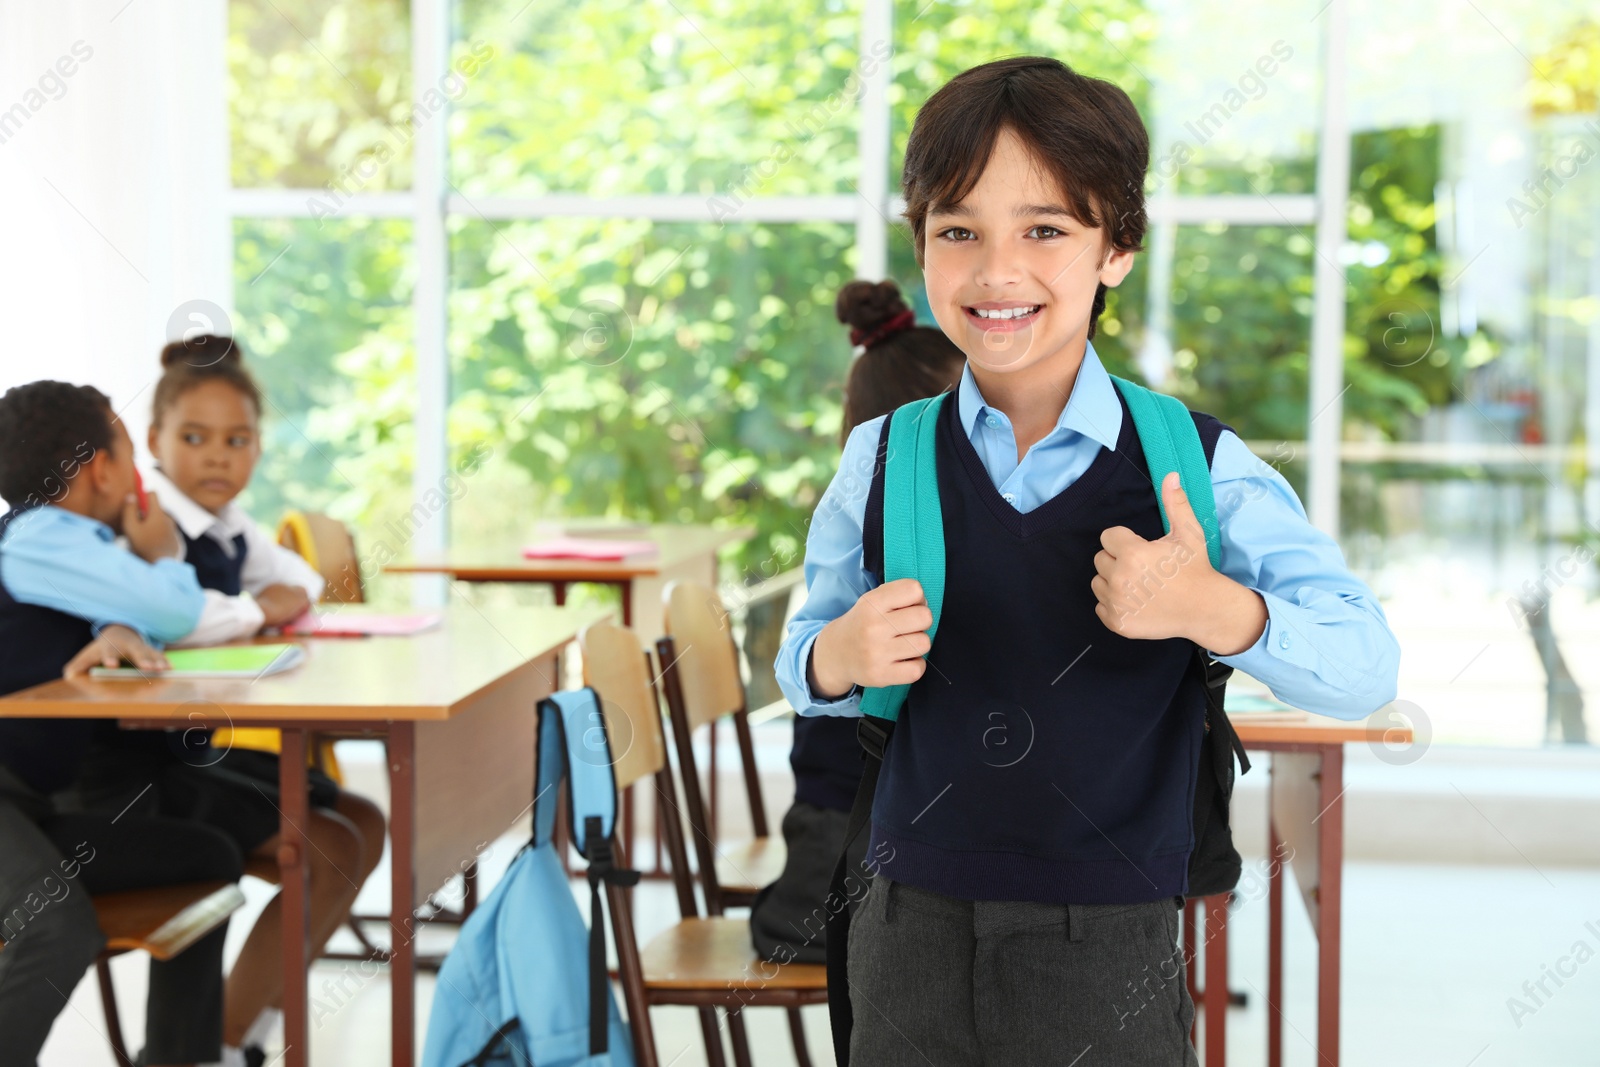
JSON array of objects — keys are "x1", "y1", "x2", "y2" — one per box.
[{"x1": 750, "y1": 280, "x2": 966, "y2": 963}]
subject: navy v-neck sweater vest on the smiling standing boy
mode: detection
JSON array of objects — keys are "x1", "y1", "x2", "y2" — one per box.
[{"x1": 862, "y1": 394, "x2": 1224, "y2": 904}]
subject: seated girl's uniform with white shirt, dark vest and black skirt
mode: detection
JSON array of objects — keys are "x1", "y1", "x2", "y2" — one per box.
[{"x1": 77, "y1": 470, "x2": 339, "y2": 856}]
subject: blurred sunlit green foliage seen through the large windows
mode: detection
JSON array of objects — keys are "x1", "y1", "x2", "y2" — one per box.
[{"x1": 229, "y1": 0, "x2": 1523, "y2": 585}]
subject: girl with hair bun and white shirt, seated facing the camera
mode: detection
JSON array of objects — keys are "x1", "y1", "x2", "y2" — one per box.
[{"x1": 66, "y1": 334, "x2": 386, "y2": 1064}]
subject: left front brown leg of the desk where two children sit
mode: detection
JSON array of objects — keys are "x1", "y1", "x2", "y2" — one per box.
[{"x1": 278, "y1": 728, "x2": 310, "y2": 1067}]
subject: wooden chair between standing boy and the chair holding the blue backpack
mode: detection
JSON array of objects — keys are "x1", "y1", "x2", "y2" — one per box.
[{"x1": 656, "y1": 581, "x2": 787, "y2": 915}]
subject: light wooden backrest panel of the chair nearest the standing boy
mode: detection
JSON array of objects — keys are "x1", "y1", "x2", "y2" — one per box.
[{"x1": 661, "y1": 581, "x2": 744, "y2": 731}]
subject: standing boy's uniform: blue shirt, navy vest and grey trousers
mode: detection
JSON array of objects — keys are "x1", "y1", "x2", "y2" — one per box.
[{"x1": 776, "y1": 346, "x2": 1398, "y2": 1065}]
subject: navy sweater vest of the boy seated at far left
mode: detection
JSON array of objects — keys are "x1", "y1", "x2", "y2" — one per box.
[{"x1": 0, "y1": 507, "x2": 96, "y2": 793}]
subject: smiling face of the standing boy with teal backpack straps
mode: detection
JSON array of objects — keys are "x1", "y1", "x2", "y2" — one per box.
[{"x1": 923, "y1": 130, "x2": 1133, "y2": 382}]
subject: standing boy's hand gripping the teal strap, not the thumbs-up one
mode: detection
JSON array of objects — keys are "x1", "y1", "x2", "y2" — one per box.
[{"x1": 808, "y1": 577, "x2": 933, "y2": 699}]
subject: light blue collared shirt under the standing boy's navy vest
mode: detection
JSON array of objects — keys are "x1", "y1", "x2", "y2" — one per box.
[{"x1": 776, "y1": 344, "x2": 1400, "y2": 718}]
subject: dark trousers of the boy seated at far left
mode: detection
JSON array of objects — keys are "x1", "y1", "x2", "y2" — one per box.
[{"x1": 0, "y1": 771, "x2": 243, "y2": 1067}]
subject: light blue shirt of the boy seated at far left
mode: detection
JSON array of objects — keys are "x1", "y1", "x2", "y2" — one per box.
[{"x1": 0, "y1": 504, "x2": 205, "y2": 645}]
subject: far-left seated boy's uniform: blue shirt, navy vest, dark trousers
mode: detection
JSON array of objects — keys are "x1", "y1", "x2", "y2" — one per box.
[{"x1": 0, "y1": 506, "x2": 243, "y2": 1067}]
